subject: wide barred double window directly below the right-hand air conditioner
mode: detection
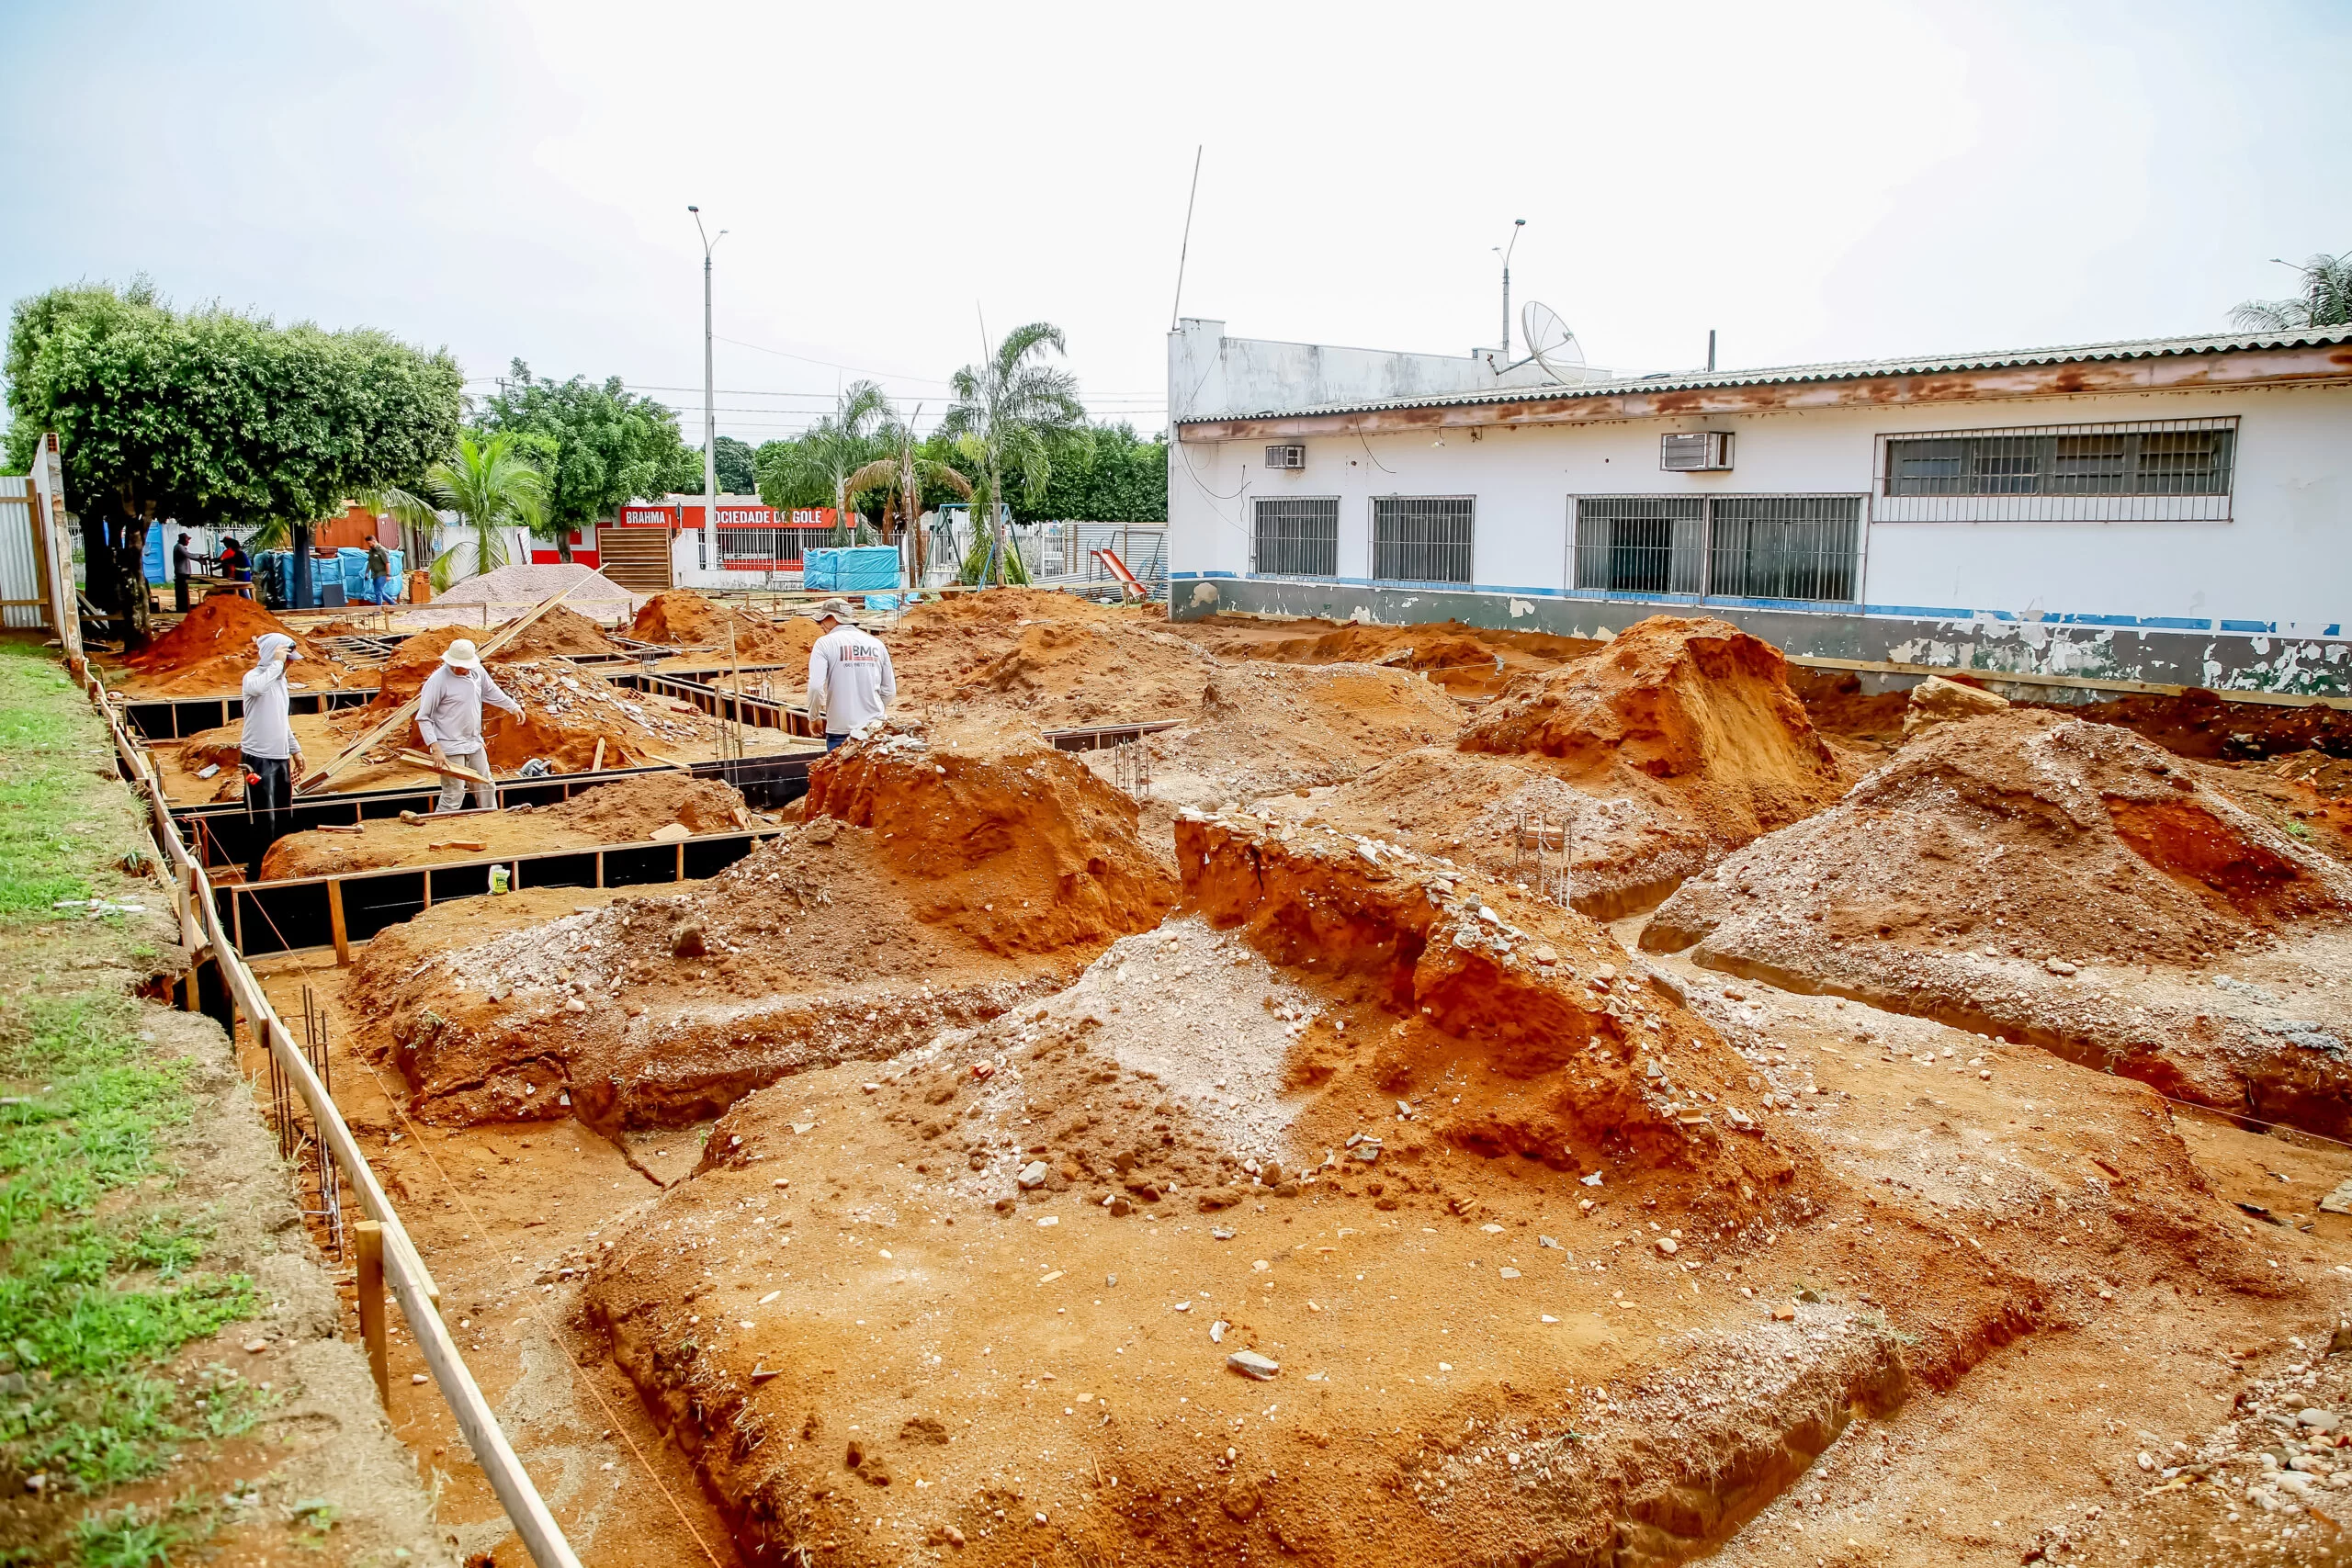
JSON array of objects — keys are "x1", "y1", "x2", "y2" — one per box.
[{"x1": 1574, "y1": 496, "x2": 1863, "y2": 604}]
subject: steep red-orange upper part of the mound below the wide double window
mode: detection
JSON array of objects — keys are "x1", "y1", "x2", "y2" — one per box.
[{"x1": 1458, "y1": 616, "x2": 1844, "y2": 844}]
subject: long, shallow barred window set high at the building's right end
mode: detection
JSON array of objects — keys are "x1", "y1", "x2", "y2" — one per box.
[{"x1": 1877, "y1": 419, "x2": 2237, "y2": 522}]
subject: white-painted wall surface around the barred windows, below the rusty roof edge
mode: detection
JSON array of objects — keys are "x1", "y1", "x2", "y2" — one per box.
[{"x1": 1169, "y1": 388, "x2": 2352, "y2": 635}]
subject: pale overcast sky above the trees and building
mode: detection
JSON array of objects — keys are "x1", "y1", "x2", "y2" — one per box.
[{"x1": 0, "y1": 0, "x2": 2352, "y2": 442}]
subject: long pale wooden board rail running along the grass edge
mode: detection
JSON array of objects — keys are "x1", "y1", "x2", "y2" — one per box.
[{"x1": 80, "y1": 660, "x2": 581, "y2": 1568}]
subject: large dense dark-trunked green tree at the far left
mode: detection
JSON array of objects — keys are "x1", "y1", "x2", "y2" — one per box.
[{"x1": 7, "y1": 277, "x2": 463, "y2": 642}]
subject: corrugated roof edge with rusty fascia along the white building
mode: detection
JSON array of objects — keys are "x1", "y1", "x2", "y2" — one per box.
[{"x1": 1176, "y1": 324, "x2": 2352, "y2": 425}]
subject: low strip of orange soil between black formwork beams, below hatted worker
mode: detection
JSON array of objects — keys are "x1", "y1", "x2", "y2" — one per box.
[{"x1": 261, "y1": 771, "x2": 751, "y2": 882}]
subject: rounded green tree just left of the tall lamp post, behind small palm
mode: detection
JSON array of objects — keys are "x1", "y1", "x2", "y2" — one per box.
[{"x1": 480, "y1": 360, "x2": 695, "y2": 559}]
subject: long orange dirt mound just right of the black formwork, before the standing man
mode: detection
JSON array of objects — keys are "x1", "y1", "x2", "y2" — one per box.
[{"x1": 345, "y1": 728, "x2": 1176, "y2": 1126}]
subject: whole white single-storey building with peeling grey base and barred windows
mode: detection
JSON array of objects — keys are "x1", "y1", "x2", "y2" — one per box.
[{"x1": 1169, "y1": 320, "x2": 2352, "y2": 694}]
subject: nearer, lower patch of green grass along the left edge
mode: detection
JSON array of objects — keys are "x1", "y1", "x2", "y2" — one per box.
[{"x1": 0, "y1": 997, "x2": 259, "y2": 1491}]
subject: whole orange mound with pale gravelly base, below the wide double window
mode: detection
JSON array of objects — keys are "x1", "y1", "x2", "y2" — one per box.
[{"x1": 1317, "y1": 616, "x2": 1844, "y2": 919}]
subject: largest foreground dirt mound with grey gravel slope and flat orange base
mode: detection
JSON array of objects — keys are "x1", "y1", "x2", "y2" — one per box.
[{"x1": 583, "y1": 816, "x2": 2301, "y2": 1568}]
